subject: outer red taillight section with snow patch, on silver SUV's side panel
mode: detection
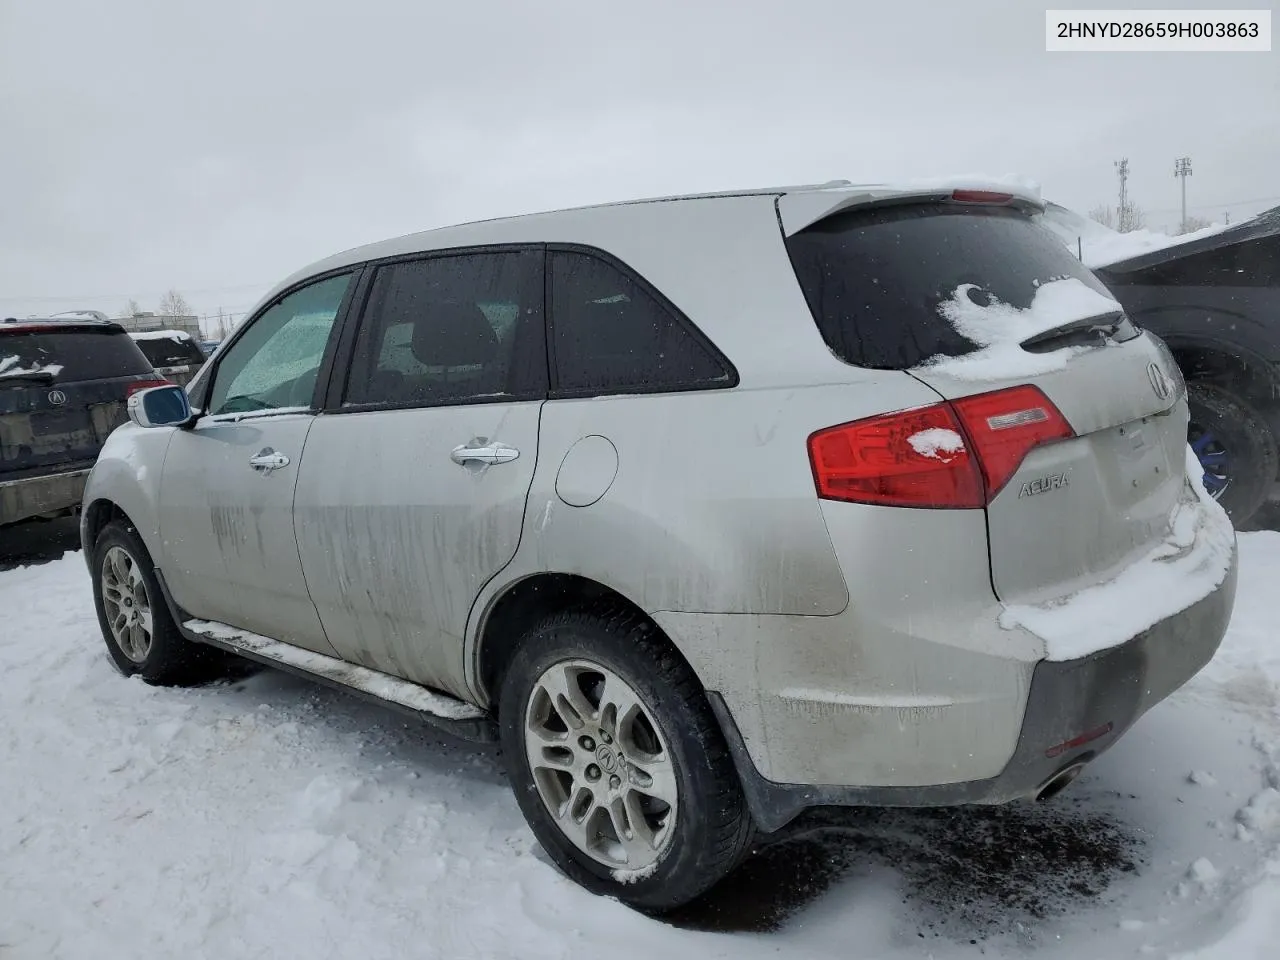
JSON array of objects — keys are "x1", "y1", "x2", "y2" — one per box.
[{"x1": 809, "y1": 403, "x2": 983, "y2": 507}]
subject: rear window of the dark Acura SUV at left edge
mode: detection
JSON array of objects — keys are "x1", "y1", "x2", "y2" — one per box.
[{"x1": 0, "y1": 328, "x2": 151, "y2": 385}]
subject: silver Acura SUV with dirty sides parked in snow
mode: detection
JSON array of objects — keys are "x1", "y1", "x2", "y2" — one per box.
[{"x1": 82, "y1": 182, "x2": 1235, "y2": 911}]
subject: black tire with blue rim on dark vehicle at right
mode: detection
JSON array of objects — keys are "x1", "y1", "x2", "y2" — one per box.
[{"x1": 1187, "y1": 383, "x2": 1280, "y2": 526}]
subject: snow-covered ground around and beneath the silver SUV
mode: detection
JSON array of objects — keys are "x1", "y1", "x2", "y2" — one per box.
[{"x1": 0, "y1": 532, "x2": 1280, "y2": 960}]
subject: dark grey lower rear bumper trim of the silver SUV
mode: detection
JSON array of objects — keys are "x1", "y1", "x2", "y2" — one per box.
[{"x1": 709, "y1": 559, "x2": 1236, "y2": 831}]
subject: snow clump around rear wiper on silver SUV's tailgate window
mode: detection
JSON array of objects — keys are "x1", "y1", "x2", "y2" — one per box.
[{"x1": 922, "y1": 276, "x2": 1121, "y2": 380}]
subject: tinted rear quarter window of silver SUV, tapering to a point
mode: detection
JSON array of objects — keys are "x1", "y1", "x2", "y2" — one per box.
[{"x1": 552, "y1": 251, "x2": 737, "y2": 396}]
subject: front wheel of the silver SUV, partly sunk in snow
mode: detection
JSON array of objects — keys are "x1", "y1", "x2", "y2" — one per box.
[{"x1": 92, "y1": 520, "x2": 219, "y2": 685}]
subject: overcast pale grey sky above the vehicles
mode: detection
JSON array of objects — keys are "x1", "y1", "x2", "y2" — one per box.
[{"x1": 0, "y1": 0, "x2": 1280, "y2": 325}]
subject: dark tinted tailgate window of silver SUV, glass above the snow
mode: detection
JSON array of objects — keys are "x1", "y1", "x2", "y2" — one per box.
[{"x1": 786, "y1": 204, "x2": 1108, "y2": 370}]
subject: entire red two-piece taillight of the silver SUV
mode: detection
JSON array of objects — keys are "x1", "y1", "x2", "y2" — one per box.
[{"x1": 809, "y1": 385, "x2": 1075, "y2": 509}]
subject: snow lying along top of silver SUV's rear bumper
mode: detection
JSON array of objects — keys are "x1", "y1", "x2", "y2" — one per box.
[{"x1": 1000, "y1": 447, "x2": 1235, "y2": 660}]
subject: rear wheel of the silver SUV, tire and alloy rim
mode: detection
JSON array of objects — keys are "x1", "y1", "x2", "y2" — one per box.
[{"x1": 498, "y1": 607, "x2": 754, "y2": 913}]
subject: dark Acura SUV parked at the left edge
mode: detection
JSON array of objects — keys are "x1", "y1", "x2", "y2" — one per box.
[{"x1": 0, "y1": 319, "x2": 168, "y2": 526}]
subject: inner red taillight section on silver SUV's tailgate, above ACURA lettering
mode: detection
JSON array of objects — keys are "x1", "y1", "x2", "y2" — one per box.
[{"x1": 951, "y1": 384, "x2": 1075, "y2": 503}]
